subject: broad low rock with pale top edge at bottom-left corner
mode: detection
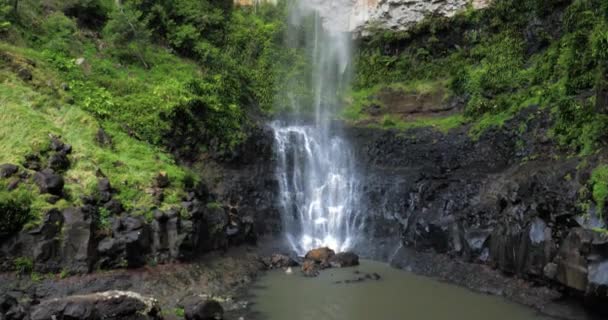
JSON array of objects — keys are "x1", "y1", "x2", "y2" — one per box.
[{"x1": 31, "y1": 291, "x2": 162, "y2": 320}]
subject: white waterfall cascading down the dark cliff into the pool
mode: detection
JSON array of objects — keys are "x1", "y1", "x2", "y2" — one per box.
[{"x1": 272, "y1": 0, "x2": 362, "y2": 255}]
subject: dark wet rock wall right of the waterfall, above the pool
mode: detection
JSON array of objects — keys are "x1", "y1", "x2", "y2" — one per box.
[{"x1": 347, "y1": 107, "x2": 608, "y2": 308}]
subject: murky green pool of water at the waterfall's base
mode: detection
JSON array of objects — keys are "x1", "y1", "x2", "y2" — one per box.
[{"x1": 253, "y1": 261, "x2": 544, "y2": 320}]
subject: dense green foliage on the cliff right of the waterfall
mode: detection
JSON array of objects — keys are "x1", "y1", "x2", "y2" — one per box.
[{"x1": 355, "y1": 0, "x2": 608, "y2": 155}]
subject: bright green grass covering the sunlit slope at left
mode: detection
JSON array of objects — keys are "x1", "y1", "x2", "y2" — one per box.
[{"x1": 0, "y1": 44, "x2": 195, "y2": 220}]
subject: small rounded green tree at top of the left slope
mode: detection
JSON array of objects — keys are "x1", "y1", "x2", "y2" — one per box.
[{"x1": 104, "y1": 3, "x2": 151, "y2": 69}]
